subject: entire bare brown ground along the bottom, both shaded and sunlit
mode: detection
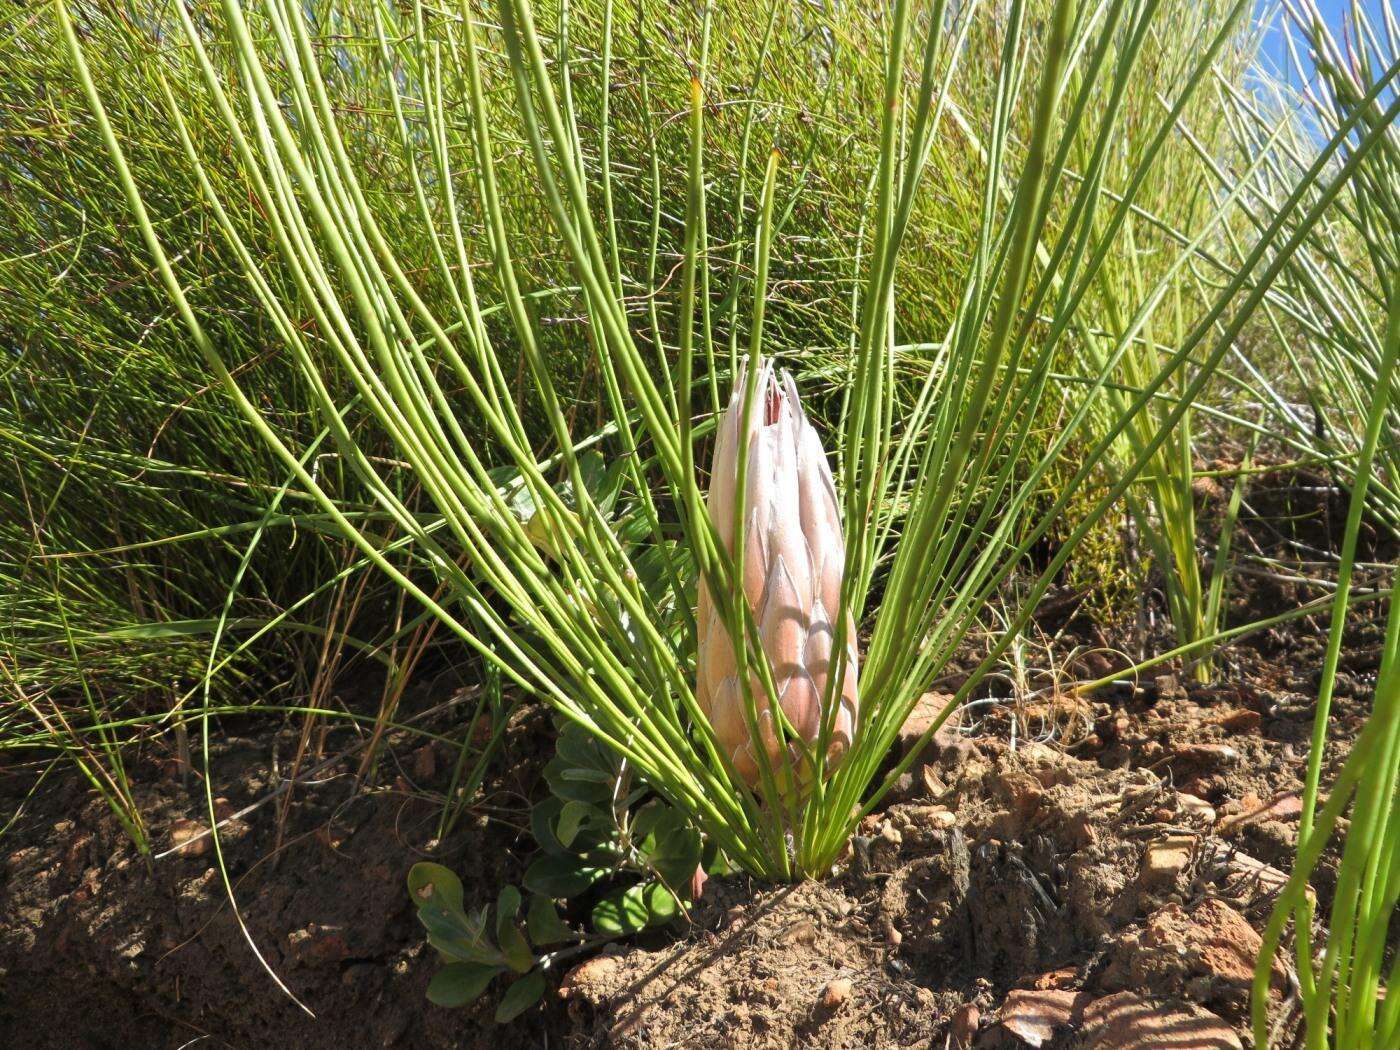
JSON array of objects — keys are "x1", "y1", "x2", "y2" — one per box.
[{"x1": 0, "y1": 473, "x2": 1379, "y2": 1050}]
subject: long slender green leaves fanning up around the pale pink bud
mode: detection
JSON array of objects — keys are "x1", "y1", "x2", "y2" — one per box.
[{"x1": 56, "y1": 0, "x2": 1372, "y2": 879}]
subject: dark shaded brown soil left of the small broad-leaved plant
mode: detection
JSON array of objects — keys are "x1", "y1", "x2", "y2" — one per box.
[{"x1": 0, "y1": 700, "x2": 568, "y2": 1050}]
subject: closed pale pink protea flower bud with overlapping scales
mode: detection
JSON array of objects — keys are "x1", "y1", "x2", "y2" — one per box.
[{"x1": 696, "y1": 364, "x2": 857, "y2": 784}]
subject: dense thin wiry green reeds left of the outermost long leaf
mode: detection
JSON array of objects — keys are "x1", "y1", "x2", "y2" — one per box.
[{"x1": 0, "y1": 0, "x2": 431, "y2": 850}]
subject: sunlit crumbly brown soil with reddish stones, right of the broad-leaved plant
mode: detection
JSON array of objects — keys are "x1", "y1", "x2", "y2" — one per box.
[{"x1": 561, "y1": 669, "x2": 1355, "y2": 1050}]
